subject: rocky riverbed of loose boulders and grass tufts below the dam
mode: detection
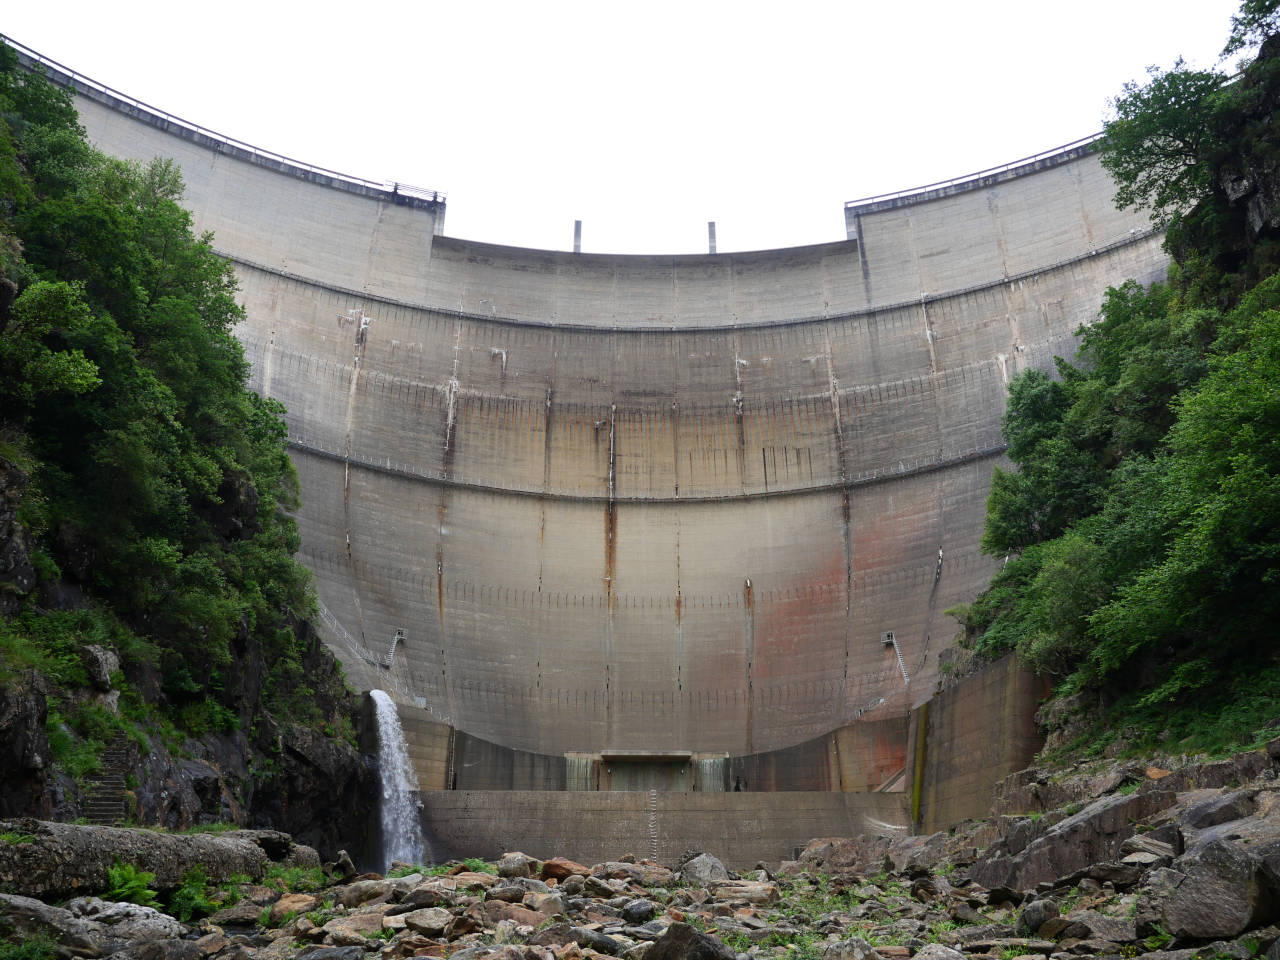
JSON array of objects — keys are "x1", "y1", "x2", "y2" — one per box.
[{"x1": 0, "y1": 741, "x2": 1280, "y2": 960}]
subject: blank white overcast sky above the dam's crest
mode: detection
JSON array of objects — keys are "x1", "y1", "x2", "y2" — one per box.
[{"x1": 0, "y1": 0, "x2": 1238, "y2": 253}]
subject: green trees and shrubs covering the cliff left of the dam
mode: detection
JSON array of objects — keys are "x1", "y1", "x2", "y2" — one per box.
[{"x1": 0, "y1": 37, "x2": 366, "y2": 834}]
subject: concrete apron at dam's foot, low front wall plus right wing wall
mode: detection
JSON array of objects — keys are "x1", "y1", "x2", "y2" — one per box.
[{"x1": 373, "y1": 655, "x2": 1047, "y2": 869}]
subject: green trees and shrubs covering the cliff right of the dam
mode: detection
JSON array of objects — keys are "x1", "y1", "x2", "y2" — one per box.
[{"x1": 956, "y1": 9, "x2": 1280, "y2": 749}]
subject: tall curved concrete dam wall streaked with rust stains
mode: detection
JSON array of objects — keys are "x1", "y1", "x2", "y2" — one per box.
[{"x1": 27, "y1": 41, "x2": 1166, "y2": 780}]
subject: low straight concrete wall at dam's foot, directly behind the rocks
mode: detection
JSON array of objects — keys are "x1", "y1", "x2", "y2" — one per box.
[{"x1": 420, "y1": 790, "x2": 906, "y2": 869}]
